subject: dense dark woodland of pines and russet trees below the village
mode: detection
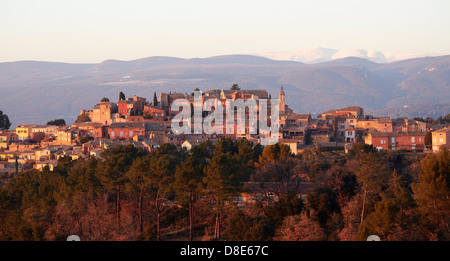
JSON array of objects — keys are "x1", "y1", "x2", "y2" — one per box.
[{"x1": 0, "y1": 139, "x2": 450, "y2": 241}]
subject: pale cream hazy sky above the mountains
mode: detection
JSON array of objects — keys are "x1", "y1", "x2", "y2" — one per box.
[{"x1": 0, "y1": 0, "x2": 450, "y2": 63}]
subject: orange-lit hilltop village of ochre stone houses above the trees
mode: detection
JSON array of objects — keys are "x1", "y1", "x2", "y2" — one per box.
[{"x1": 0, "y1": 86, "x2": 450, "y2": 174}]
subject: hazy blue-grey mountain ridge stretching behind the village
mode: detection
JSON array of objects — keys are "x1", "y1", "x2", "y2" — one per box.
[{"x1": 0, "y1": 55, "x2": 450, "y2": 128}]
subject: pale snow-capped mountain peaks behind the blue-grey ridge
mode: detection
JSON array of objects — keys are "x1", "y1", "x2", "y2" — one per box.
[{"x1": 255, "y1": 47, "x2": 439, "y2": 64}]
